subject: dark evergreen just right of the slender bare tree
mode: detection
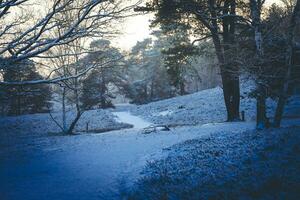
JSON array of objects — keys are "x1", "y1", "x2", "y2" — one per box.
[{"x1": 80, "y1": 40, "x2": 122, "y2": 109}]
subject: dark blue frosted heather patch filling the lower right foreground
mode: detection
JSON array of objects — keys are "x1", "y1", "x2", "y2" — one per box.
[{"x1": 127, "y1": 124, "x2": 300, "y2": 200}]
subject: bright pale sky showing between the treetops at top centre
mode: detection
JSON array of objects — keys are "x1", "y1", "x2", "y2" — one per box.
[{"x1": 112, "y1": 0, "x2": 281, "y2": 50}]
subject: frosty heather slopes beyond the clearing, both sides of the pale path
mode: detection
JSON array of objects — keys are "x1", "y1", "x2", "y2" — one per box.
[{"x1": 0, "y1": 87, "x2": 300, "y2": 141}]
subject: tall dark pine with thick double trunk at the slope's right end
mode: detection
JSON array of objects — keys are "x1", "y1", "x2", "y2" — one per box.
[{"x1": 136, "y1": 0, "x2": 245, "y2": 121}]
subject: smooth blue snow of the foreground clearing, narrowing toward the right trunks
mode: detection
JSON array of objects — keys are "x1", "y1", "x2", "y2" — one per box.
[{"x1": 0, "y1": 120, "x2": 254, "y2": 199}]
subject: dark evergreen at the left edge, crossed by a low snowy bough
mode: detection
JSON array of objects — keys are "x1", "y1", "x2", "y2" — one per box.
[{"x1": 0, "y1": 61, "x2": 51, "y2": 115}]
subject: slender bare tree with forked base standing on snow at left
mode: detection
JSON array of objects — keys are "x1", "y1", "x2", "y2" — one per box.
[{"x1": 47, "y1": 0, "x2": 106, "y2": 134}]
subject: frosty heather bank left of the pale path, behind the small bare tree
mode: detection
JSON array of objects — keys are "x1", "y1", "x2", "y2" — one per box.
[{"x1": 0, "y1": 110, "x2": 129, "y2": 145}]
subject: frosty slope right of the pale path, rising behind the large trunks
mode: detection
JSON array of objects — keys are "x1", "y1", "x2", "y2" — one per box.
[{"x1": 131, "y1": 87, "x2": 300, "y2": 125}]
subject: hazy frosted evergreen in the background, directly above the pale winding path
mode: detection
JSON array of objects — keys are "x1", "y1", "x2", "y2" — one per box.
[{"x1": 124, "y1": 36, "x2": 175, "y2": 104}]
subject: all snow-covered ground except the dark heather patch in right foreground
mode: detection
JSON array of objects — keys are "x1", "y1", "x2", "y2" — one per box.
[{"x1": 0, "y1": 88, "x2": 300, "y2": 200}]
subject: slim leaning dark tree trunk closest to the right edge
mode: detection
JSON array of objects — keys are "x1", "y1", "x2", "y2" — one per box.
[{"x1": 273, "y1": 0, "x2": 300, "y2": 127}]
